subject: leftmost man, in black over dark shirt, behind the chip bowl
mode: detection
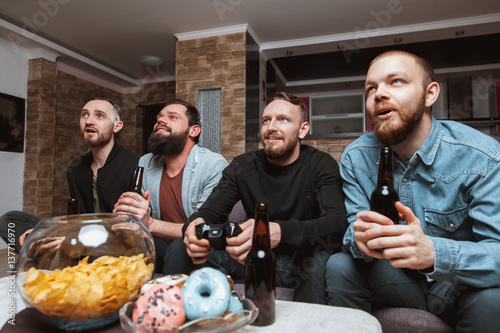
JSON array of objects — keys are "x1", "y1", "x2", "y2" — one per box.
[{"x1": 0, "y1": 98, "x2": 139, "y2": 252}]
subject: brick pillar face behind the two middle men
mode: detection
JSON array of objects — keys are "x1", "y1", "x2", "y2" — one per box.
[{"x1": 175, "y1": 32, "x2": 246, "y2": 161}]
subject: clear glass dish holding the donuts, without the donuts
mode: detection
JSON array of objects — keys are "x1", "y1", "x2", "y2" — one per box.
[{"x1": 120, "y1": 290, "x2": 259, "y2": 333}]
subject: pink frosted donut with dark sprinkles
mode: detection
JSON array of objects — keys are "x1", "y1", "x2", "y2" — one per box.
[{"x1": 132, "y1": 283, "x2": 186, "y2": 330}]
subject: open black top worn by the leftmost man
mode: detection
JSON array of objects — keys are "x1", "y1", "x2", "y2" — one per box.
[{"x1": 66, "y1": 143, "x2": 139, "y2": 214}]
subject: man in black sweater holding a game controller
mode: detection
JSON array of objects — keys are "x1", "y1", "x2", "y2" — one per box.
[{"x1": 167, "y1": 93, "x2": 347, "y2": 304}]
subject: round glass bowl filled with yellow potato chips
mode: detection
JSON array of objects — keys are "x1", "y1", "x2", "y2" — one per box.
[{"x1": 16, "y1": 214, "x2": 155, "y2": 330}]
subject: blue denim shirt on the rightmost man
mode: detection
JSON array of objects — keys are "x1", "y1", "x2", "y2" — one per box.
[{"x1": 340, "y1": 118, "x2": 500, "y2": 288}]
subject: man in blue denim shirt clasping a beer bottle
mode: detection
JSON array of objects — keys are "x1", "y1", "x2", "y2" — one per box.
[{"x1": 326, "y1": 51, "x2": 500, "y2": 332}]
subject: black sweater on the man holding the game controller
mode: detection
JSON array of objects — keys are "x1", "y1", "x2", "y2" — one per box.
[{"x1": 184, "y1": 145, "x2": 347, "y2": 253}]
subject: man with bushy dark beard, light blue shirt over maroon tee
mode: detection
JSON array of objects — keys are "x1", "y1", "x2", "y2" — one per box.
[{"x1": 114, "y1": 99, "x2": 228, "y2": 273}]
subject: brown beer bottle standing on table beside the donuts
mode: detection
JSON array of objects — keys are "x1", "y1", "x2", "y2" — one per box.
[{"x1": 245, "y1": 203, "x2": 276, "y2": 326}]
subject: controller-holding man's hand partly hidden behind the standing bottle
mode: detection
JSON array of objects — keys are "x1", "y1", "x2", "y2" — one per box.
[{"x1": 226, "y1": 219, "x2": 281, "y2": 265}]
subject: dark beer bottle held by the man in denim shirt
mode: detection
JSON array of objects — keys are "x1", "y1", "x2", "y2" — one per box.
[{"x1": 370, "y1": 147, "x2": 399, "y2": 224}]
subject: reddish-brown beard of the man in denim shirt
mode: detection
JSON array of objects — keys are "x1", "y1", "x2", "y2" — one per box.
[{"x1": 369, "y1": 96, "x2": 425, "y2": 146}]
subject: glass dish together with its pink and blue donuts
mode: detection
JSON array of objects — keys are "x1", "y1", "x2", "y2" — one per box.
[{"x1": 119, "y1": 268, "x2": 259, "y2": 333}]
